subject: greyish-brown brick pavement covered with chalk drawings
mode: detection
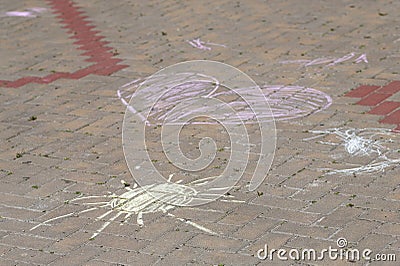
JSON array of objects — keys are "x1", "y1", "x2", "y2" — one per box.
[{"x1": 0, "y1": 0, "x2": 400, "y2": 265}]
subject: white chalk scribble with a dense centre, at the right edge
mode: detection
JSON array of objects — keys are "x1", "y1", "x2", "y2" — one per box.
[{"x1": 303, "y1": 128, "x2": 400, "y2": 175}]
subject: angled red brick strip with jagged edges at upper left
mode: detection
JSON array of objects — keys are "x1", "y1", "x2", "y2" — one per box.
[{"x1": 0, "y1": 0, "x2": 128, "y2": 88}]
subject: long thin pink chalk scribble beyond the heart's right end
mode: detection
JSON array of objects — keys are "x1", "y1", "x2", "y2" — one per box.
[{"x1": 280, "y1": 52, "x2": 368, "y2": 67}]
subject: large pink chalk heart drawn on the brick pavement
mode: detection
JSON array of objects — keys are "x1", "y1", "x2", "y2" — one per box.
[{"x1": 117, "y1": 73, "x2": 332, "y2": 125}]
